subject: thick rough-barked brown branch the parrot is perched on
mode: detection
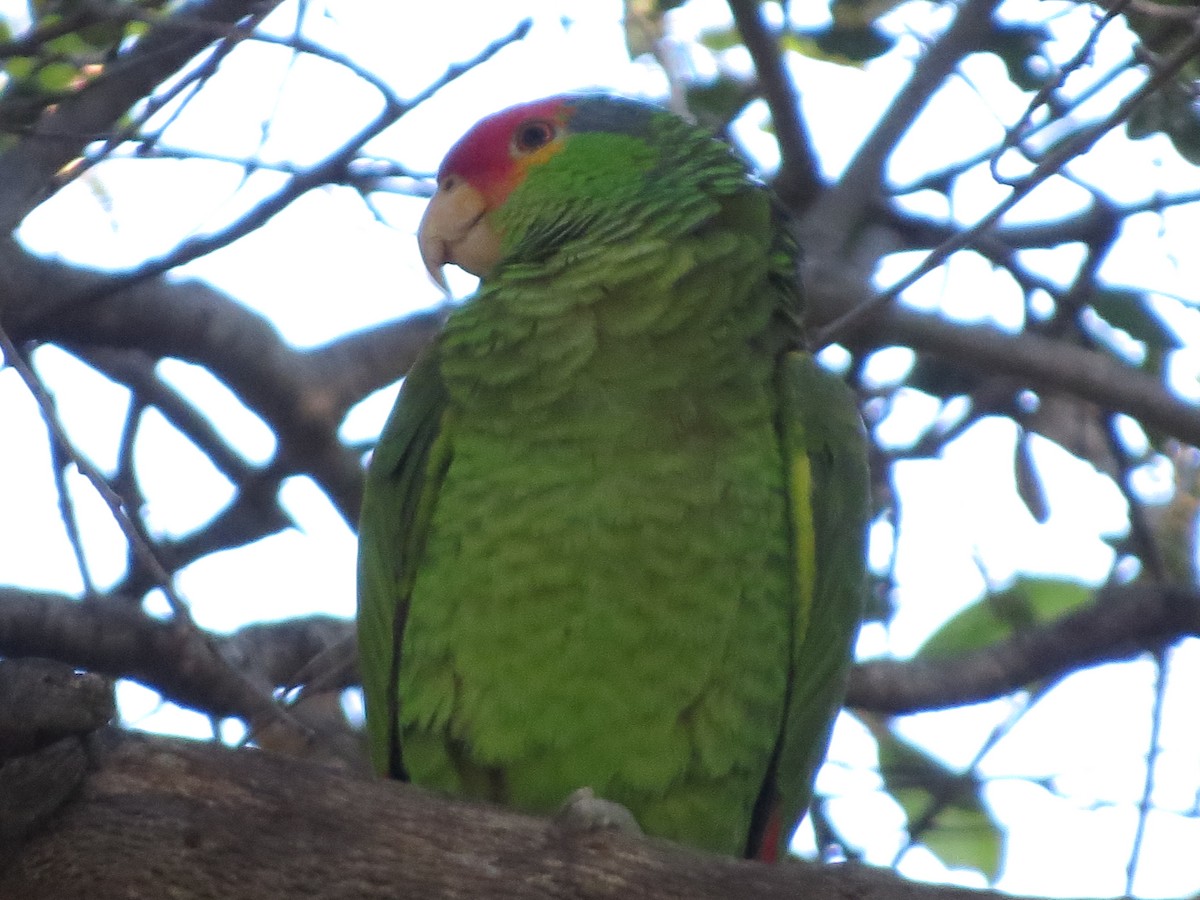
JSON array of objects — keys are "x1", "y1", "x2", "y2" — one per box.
[{"x1": 0, "y1": 730, "x2": 1017, "y2": 900}]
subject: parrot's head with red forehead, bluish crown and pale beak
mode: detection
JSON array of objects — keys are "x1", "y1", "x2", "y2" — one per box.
[{"x1": 418, "y1": 94, "x2": 730, "y2": 288}]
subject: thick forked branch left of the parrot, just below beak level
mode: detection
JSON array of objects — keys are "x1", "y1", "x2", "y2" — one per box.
[{"x1": 0, "y1": 242, "x2": 444, "y2": 524}]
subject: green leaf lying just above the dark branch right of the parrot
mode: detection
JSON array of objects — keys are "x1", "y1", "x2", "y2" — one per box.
[{"x1": 916, "y1": 577, "x2": 1094, "y2": 659}]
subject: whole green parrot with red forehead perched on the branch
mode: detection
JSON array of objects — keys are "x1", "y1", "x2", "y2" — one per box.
[{"x1": 359, "y1": 95, "x2": 869, "y2": 858}]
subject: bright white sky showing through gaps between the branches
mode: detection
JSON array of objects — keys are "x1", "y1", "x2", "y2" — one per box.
[{"x1": 0, "y1": 0, "x2": 1200, "y2": 896}]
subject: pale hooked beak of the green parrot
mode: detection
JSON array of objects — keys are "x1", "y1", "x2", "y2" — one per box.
[{"x1": 416, "y1": 175, "x2": 500, "y2": 293}]
